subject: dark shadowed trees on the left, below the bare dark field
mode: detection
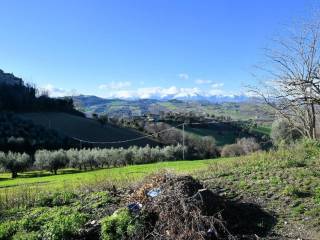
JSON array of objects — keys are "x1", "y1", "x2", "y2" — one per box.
[{"x1": 0, "y1": 112, "x2": 70, "y2": 153}]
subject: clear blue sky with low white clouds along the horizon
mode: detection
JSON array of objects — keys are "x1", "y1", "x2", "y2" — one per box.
[{"x1": 0, "y1": 0, "x2": 317, "y2": 98}]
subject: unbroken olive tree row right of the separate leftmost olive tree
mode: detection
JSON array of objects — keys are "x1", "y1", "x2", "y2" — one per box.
[{"x1": 35, "y1": 145, "x2": 187, "y2": 173}]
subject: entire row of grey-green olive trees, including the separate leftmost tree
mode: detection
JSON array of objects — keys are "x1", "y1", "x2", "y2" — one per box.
[{"x1": 0, "y1": 145, "x2": 188, "y2": 178}]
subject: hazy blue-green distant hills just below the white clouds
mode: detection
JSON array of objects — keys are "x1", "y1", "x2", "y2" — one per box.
[{"x1": 73, "y1": 95, "x2": 273, "y2": 121}]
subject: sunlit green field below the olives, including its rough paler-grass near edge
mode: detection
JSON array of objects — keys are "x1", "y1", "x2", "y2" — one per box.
[{"x1": 0, "y1": 159, "x2": 216, "y2": 208}]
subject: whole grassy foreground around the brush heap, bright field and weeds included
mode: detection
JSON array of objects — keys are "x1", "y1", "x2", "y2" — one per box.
[{"x1": 0, "y1": 140, "x2": 320, "y2": 239}]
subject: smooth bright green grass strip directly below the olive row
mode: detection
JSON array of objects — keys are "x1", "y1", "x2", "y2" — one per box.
[{"x1": 0, "y1": 160, "x2": 216, "y2": 193}]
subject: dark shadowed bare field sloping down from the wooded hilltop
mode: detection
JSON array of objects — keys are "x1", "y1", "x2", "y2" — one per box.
[{"x1": 20, "y1": 112, "x2": 156, "y2": 147}]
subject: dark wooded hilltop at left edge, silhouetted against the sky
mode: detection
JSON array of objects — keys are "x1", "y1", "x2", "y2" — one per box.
[{"x1": 0, "y1": 70, "x2": 83, "y2": 116}]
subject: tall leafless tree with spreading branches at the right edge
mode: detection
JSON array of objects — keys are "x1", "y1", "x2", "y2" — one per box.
[{"x1": 251, "y1": 18, "x2": 320, "y2": 139}]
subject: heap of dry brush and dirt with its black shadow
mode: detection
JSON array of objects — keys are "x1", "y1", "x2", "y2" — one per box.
[{"x1": 128, "y1": 174, "x2": 274, "y2": 240}]
